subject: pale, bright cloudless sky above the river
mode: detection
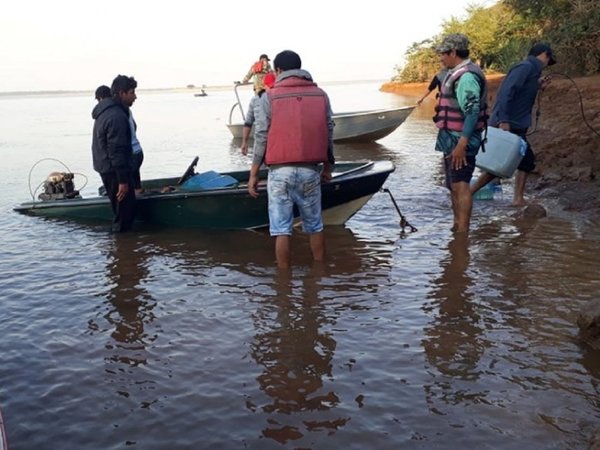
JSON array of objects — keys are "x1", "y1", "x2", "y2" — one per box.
[{"x1": 0, "y1": 0, "x2": 495, "y2": 92}]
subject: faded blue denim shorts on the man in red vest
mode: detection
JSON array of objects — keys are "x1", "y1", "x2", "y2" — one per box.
[{"x1": 267, "y1": 166, "x2": 323, "y2": 236}]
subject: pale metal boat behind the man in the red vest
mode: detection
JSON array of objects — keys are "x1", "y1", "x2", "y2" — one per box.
[{"x1": 227, "y1": 84, "x2": 415, "y2": 142}]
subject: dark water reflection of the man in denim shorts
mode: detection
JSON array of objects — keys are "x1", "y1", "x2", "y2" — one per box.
[{"x1": 251, "y1": 269, "x2": 349, "y2": 443}]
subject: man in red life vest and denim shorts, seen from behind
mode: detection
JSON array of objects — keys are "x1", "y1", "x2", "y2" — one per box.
[{"x1": 248, "y1": 50, "x2": 335, "y2": 269}]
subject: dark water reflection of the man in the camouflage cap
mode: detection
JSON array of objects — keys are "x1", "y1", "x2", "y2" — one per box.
[{"x1": 423, "y1": 233, "x2": 487, "y2": 404}]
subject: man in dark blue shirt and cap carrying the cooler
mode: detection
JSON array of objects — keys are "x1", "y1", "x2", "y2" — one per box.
[{"x1": 471, "y1": 44, "x2": 556, "y2": 206}]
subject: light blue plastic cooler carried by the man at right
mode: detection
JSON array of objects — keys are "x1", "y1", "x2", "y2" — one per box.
[{"x1": 475, "y1": 127, "x2": 527, "y2": 178}]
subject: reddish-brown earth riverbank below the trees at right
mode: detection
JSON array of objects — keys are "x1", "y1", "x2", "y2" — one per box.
[{"x1": 380, "y1": 72, "x2": 600, "y2": 219}]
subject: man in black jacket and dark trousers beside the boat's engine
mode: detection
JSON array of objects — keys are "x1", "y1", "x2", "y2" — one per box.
[{"x1": 92, "y1": 75, "x2": 137, "y2": 232}]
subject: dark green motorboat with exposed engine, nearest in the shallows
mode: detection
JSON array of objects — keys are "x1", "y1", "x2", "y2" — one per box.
[{"x1": 13, "y1": 157, "x2": 395, "y2": 229}]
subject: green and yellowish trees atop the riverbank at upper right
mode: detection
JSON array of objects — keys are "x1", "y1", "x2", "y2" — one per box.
[{"x1": 394, "y1": 0, "x2": 600, "y2": 83}]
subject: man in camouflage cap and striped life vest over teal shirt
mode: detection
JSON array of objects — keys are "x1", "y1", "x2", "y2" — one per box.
[{"x1": 433, "y1": 33, "x2": 487, "y2": 233}]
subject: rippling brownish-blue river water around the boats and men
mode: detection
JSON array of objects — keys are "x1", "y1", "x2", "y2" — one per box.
[{"x1": 0, "y1": 83, "x2": 600, "y2": 450}]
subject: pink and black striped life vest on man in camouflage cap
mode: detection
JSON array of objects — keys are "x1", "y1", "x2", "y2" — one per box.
[{"x1": 433, "y1": 62, "x2": 488, "y2": 132}]
